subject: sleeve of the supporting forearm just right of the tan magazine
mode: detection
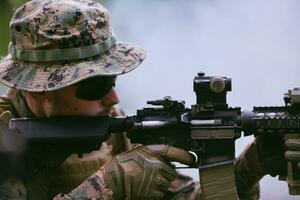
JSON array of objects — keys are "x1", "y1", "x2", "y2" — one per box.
[{"x1": 234, "y1": 142, "x2": 264, "y2": 200}]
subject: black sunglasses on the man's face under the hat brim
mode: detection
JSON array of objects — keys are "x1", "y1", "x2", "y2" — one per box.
[{"x1": 75, "y1": 76, "x2": 116, "y2": 101}]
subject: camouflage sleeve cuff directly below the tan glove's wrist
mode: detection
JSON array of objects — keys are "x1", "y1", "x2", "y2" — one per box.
[{"x1": 53, "y1": 170, "x2": 113, "y2": 200}]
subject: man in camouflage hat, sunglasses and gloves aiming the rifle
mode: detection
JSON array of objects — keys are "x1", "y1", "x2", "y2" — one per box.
[{"x1": 0, "y1": 0, "x2": 298, "y2": 200}]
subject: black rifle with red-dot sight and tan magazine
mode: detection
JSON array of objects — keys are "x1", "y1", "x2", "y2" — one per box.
[{"x1": 4, "y1": 73, "x2": 300, "y2": 199}]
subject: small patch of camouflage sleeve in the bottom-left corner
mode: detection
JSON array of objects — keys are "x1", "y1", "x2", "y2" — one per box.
[{"x1": 0, "y1": 179, "x2": 27, "y2": 200}]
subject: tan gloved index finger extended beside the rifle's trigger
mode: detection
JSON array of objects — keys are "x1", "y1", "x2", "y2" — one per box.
[{"x1": 147, "y1": 144, "x2": 196, "y2": 166}]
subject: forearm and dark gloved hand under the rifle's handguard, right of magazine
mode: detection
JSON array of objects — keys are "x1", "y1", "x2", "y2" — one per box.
[{"x1": 234, "y1": 134, "x2": 286, "y2": 199}]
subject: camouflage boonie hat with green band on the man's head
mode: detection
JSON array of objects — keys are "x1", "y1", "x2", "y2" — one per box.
[{"x1": 0, "y1": 0, "x2": 145, "y2": 92}]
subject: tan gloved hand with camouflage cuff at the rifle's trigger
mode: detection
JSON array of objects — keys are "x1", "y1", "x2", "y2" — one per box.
[{"x1": 54, "y1": 145, "x2": 198, "y2": 200}]
